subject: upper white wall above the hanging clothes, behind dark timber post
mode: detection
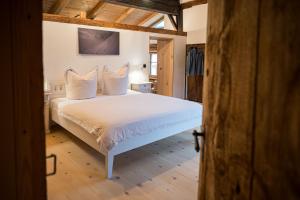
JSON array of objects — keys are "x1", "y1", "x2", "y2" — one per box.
[{"x1": 165, "y1": 0, "x2": 207, "y2": 44}]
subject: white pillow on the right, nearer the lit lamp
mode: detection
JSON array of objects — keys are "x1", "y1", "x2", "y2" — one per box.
[{"x1": 102, "y1": 65, "x2": 129, "y2": 95}]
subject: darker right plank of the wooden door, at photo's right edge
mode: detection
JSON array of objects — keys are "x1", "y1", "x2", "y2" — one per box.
[{"x1": 252, "y1": 0, "x2": 300, "y2": 200}]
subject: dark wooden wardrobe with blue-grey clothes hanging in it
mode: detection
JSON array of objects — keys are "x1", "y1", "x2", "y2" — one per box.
[{"x1": 185, "y1": 44, "x2": 205, "y2": 103}]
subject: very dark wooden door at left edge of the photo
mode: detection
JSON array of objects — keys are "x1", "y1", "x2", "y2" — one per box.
[{"x1": 0, "y1": 0, "x2": 47, "y2": 200}]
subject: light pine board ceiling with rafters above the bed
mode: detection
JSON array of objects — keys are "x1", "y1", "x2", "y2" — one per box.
[{"x1": 43, "y1": 0, "x2": 163, "y2": 26}]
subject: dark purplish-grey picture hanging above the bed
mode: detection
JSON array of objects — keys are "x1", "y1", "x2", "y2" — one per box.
[{"x1": 78, "y1": 28, "x2": 120, "y2": 55}]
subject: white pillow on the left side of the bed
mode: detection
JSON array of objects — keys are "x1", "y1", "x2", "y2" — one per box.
[{"x1": 65, "y1": 69, "x2": 98, "y2": 99}]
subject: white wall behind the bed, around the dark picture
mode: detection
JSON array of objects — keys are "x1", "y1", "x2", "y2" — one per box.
[{"x1": 43, "y1": 21, "x2": 186, "y2": 98}]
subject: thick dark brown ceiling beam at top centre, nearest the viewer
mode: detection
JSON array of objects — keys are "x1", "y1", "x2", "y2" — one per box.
[{"x1": 104, "y1": 0, "x2": 180, "y2": 15}]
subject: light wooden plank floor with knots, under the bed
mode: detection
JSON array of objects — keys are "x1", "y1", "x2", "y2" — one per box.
[{"x1": 46, "y1": 128, "x2": 199, "y2": 200}]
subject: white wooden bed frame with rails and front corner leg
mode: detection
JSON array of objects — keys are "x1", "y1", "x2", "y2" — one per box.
[{"x1": 51, "y1": 106, "x2": 201, "y2": 178}]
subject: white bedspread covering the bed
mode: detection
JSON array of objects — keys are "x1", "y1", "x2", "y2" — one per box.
[{"x1": 52, "y1": 93, "x2": 202, "y2": 150}]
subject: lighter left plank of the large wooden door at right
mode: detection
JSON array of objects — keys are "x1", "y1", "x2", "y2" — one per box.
[{"x1": 199, "y1": 0, "x2": 258, "y2": 200}]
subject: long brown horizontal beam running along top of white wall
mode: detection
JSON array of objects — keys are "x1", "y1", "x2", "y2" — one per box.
[{"x1": 43, "y1": 13, "x2": 187, "y2": 36}]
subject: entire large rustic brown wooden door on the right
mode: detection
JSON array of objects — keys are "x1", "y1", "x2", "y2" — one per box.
[{"x1": 199, "y1": 0, "x2": 300, "y2": 200}]
